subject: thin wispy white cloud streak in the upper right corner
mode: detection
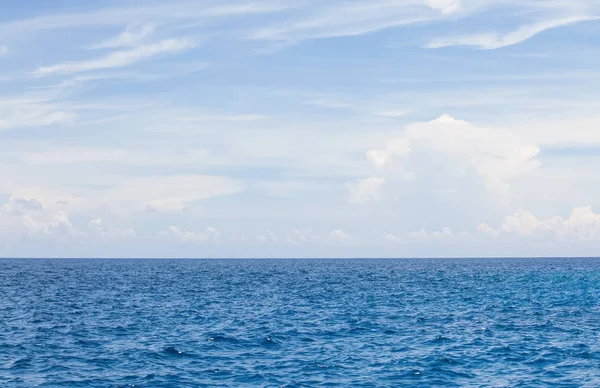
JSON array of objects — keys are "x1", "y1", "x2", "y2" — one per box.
[{"x1": 425, "y1": 16, "x2": 596, "y2": 50}]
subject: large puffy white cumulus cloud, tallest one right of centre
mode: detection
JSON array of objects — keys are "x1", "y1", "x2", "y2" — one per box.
[{"x1": 363, "y1": 115, "x2": 540, "y2": 198}]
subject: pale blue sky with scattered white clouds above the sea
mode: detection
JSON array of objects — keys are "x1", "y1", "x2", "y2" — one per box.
[{"x1": 0, "y1": 0, "x2": 600, "y2": 258}]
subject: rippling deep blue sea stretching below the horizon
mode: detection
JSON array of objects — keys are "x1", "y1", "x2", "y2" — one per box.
[{"x1": 0, "y1": 259, "x2": 600, "y2": 387}]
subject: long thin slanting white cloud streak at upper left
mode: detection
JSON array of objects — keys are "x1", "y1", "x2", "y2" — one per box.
[{"x1": 34, "y1": 39, "x2": 196, "y2": 76}]
